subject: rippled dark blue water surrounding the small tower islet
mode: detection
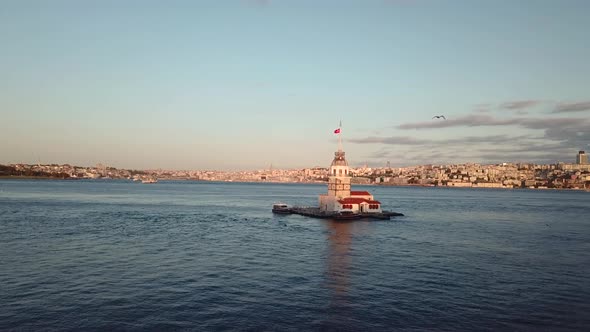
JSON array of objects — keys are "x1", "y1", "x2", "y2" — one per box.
[{"x1": 0, "y1": 180, "x2": 590, "y2": 331}]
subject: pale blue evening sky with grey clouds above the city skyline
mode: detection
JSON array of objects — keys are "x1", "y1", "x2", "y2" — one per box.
[{"x1": 0, "y1": 0, "x2": 590, "y2": 170}]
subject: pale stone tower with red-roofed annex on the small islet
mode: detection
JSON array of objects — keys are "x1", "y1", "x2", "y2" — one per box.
[{"x1": 319, "y1": 129, "x2": 382, "y2": 213}]
